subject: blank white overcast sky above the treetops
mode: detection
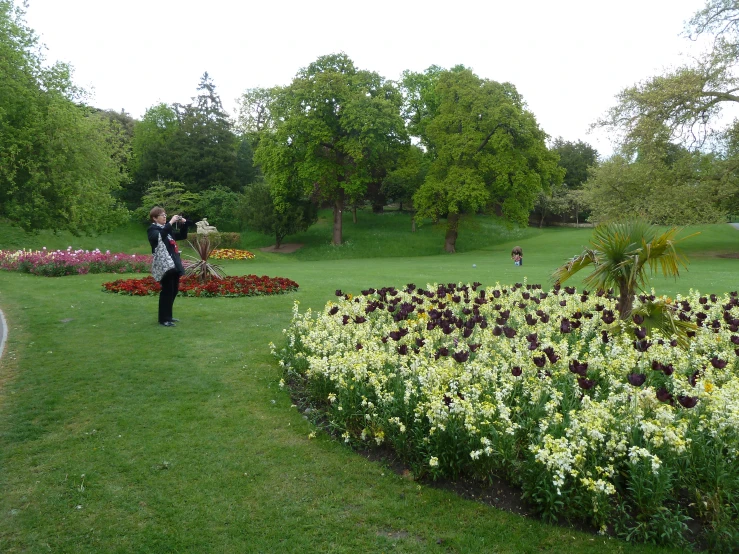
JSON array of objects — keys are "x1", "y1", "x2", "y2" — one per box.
[{"x1": 21, "y1": 0, "x2": 705, "y2": 154}]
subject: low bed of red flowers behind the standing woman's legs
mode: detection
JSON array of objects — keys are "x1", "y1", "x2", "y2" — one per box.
[{"x1": 103, "y1": 275, "x2": 298, "y2": 296}]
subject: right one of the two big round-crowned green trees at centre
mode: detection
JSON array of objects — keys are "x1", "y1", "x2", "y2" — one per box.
[{"x1": 413, "y1": 68, "x2": 564, "y2": 252}]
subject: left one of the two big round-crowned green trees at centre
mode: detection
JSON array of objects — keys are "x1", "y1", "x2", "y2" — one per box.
[{"x1": 255, "y1": 53, "x2": 407, "y2": 245}]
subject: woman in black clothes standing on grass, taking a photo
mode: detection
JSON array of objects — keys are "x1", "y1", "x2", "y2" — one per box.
[{"x1": 147, "y1": 206, "x2": 187, "y2": 327}]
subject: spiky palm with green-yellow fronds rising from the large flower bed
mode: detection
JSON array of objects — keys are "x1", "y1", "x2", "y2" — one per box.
[{"x1": 553, "y1": 220, "x2": 692, "y2": 320}]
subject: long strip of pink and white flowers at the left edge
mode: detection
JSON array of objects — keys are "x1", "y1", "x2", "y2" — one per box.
[{"x1": 0, "y1": 246, "x2": 151, "y2": 277}]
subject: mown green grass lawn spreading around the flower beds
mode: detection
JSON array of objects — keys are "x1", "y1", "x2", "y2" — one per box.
[{"x1": 0, "y1": 213, "x2": 739, "y2": 553}]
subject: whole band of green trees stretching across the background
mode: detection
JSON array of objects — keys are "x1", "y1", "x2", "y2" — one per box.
[{"x1": 0, "y1": 0, "x2": 739, "y2": 246}]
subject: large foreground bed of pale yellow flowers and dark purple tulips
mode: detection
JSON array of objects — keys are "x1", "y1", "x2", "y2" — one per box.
[{"x1": 272, "y1": 283, "x2": 739, "y2": 546}]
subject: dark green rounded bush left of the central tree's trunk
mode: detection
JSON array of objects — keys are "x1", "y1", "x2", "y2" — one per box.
[{"x1": 241, "y1": 182, "x2": 318, "y2": 248}]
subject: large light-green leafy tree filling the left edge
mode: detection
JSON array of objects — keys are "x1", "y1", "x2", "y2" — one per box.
[{"x1": 0, "y1": 0, "x2": 126, "y2": 233}]
